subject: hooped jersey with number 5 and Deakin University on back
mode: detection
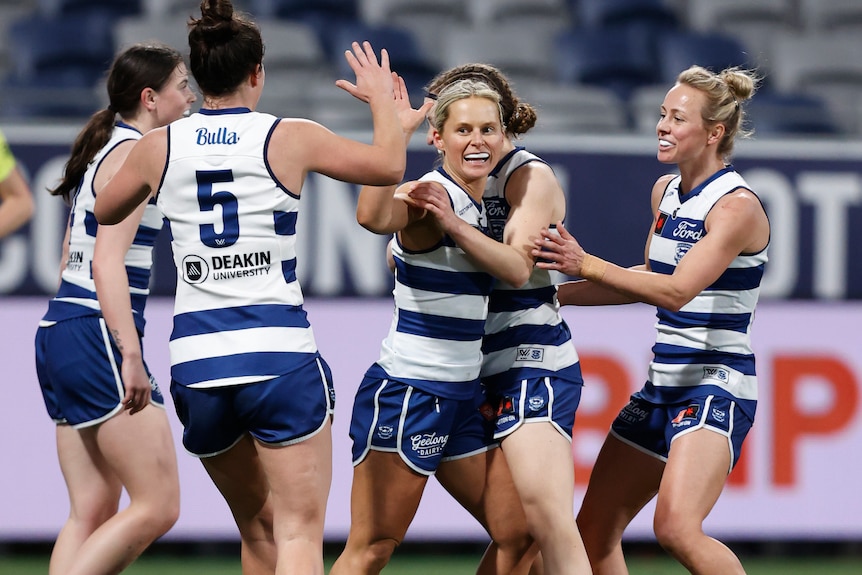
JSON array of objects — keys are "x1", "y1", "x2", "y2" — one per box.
[{"x1": 157, "y1": 108, "x2": 318, "y2": 387}]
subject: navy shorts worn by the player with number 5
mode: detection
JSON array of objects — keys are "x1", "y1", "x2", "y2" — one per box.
[{"x1": 171, "y1": 356, "x2": 335, "y2": 458}]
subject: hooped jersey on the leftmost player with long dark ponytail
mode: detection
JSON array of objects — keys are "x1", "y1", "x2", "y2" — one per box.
[{"x1": 40, "y1": 122, "x2": 163, "y2": 335}]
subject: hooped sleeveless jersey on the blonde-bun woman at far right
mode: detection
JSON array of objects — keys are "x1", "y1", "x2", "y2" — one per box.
[{"x1": 642, "y1": 166, "x2": 767, "y2": 420}]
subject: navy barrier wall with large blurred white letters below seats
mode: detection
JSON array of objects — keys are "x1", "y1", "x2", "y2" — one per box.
[{"x1": 0, "y1": 126, "x2": 862, "y2": 300}]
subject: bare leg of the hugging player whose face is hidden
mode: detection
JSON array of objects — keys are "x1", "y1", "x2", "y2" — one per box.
[{"x1": 503, "y1": 422, "x2": 590, "y2": 575}]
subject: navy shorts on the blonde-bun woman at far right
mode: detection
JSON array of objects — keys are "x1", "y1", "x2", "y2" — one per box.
[{"x1": 611, "y1": 394, "x2": 753, "y2": 473}]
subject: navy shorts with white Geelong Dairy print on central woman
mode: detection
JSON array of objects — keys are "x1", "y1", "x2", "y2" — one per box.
[{"x1": 350, "y1": 377, "x2": 497, "y2": 475}]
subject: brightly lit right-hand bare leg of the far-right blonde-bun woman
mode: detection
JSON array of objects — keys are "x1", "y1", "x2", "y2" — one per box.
[{"x1": 654, "y1": 429, "x2": 745, "y2": 575}]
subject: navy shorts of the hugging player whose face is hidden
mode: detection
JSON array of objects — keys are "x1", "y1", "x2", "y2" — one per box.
[{"x1": 485, "y1": 376, "x2": 583, "y2": 441}]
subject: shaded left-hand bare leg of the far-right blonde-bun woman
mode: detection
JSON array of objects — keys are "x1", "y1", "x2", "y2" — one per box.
[{"x1": 578, "y1": 435, "x2": 664, "y2": 575}]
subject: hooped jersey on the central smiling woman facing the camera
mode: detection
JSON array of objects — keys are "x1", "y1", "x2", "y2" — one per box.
[{"x1": 368, "y1": 169, "x2": 493, "y2": 399}]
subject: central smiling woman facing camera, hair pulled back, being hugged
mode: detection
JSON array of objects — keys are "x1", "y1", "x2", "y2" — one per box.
[{"x1": 332, "y1": 80, "x2": 536, "y2": 575}]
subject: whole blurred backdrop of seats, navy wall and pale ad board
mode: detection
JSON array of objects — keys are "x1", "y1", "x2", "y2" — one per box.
[{"x1": 0, "y1": 0, "x2": 862, "y2": 573}]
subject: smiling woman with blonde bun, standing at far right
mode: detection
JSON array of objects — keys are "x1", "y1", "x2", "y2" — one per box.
[{"x1": 533, "y1": 66, "x2": 770, "y2": 575}]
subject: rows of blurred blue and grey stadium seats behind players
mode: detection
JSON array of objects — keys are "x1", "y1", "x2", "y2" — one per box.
[{"x1": 0, "y1": 0, "x2": 862, "y2": 137}]
